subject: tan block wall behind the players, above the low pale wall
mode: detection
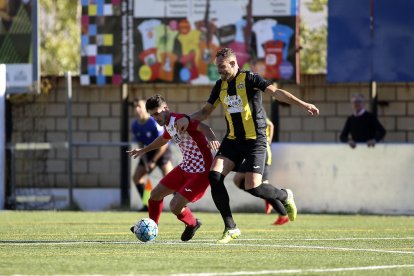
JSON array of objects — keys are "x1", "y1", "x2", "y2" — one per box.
[{"x1": 9, "y1": 75, "x2": 414, "y2": 188}]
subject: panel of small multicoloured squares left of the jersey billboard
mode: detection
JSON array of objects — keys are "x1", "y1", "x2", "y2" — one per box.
[{"x1": 80, "y1": 0, "x2": 123, "y2": 85}]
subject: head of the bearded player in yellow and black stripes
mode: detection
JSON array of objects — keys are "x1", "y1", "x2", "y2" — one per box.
[{"x1": 216, "y1": 48, "x2": 239, "y2": 81}]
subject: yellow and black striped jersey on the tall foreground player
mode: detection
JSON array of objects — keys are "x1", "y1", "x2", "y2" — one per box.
[{"x1": 208, "y1": 70, "x2": 270, "y2": 140}]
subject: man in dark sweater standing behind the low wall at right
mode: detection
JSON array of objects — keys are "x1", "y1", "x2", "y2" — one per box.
[{"x1": 339, "y1": 93, "x2": 386, "y2": 148}]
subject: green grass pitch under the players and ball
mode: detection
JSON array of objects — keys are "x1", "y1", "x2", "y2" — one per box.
[{"x1": 0, "y1": 211, "x2": 414, "y2": 276}]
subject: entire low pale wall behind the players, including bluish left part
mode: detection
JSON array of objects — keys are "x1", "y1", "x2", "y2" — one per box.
[{"x1": 22, "y1": 143, "x2": 414, "y2": 215}]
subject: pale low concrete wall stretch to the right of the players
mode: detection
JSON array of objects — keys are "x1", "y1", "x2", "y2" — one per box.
[{"x1": 271, "y1": 143, "x2": 414, "y2": 215}]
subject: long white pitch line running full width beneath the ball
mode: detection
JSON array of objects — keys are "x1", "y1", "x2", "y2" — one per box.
[{"x1": 0, "y1": 239, "x2": 414, "y2": 254}]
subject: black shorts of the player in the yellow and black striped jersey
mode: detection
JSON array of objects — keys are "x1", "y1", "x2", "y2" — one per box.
[{"x1": 217, "y1": 138, "x2": 267, "y2": 175}]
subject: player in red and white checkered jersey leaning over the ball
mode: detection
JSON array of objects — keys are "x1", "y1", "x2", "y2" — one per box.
[{"x1": 127, "y1": 95, "x2": 220, "y2": 241}]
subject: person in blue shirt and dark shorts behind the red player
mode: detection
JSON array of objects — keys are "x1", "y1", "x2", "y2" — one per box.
[{"x1": 131, "y1": 99, "x2": 173, "y2": 211}]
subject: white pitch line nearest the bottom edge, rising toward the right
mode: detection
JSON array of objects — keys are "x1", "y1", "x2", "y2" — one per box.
[{"x1": 170, "y1": 264, "x2": 414, "y2": 276}]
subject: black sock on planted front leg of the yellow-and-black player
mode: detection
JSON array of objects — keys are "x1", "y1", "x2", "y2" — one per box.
[{"x1": 208, "y1": 171, "x2": 236, "y2": 229}]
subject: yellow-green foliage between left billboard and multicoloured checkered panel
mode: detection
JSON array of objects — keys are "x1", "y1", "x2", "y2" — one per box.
[{"x1": 39, "y1": 0, "x2": 80, "y2": 75}]
